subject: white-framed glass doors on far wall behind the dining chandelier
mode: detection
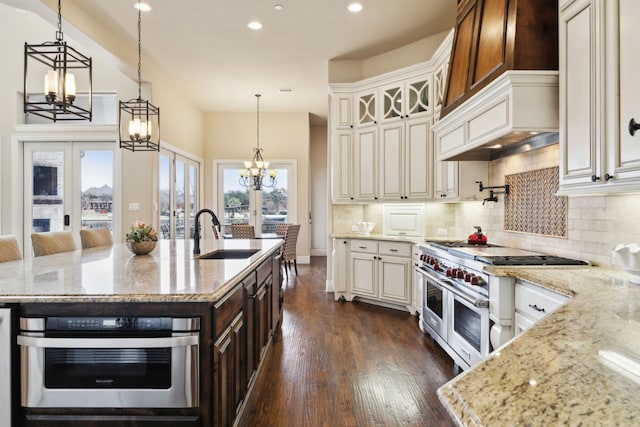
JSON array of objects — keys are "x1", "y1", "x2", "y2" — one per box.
[{"x1": 216, "y1": 161, "x2": 296, "y2": 235}]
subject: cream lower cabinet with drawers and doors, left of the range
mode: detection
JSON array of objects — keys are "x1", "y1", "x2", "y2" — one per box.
[{"x1": 334, "y1": 239, "x2": 414, "y2": 313}]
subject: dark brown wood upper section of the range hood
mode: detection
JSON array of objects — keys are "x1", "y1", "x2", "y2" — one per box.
[{"x1": 441, "y1": 0, "x2": 558, "y2": 117}]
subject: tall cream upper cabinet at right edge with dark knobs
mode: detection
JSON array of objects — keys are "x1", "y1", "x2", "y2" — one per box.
[{"x1": 560, "y1": 0, "x2": 640, "y2": 195}]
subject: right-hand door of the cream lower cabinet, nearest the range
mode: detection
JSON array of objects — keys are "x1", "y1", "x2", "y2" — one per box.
[{"x1": 378, "y1": 256, "x2": 411, "y2": 305}]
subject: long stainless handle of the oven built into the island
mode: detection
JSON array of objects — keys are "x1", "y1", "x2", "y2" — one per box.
[{"x1": 17, "y1": 335, "x2": 198, "y2": 348}]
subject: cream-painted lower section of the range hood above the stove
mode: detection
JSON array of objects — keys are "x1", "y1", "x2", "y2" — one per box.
[{"x1": 433, "y1": 70, "x2": 559, "y2": 161}]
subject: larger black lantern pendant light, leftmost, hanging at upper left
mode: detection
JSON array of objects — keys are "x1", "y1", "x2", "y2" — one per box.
[{"x1": 23, "y1": 0, "x2": 93, "y2": 122}]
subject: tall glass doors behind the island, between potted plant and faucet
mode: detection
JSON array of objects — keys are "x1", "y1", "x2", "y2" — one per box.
[{"x1": 158, "y1": 150, "x2": 200, "y2": 239}]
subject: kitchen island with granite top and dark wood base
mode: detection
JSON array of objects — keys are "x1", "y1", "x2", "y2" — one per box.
[{"x1": 0, "y1": 239, "x2": 282, "y2": 426}]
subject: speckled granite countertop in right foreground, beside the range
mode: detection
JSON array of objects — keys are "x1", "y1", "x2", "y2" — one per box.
[{"x1": 438, "y1": 267, "x2": 640, "y2": 426}]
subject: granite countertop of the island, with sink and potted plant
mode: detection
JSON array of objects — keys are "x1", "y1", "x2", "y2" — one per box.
[{"x1": 0, "y1": 239, "x2": 282, "y2": 303}]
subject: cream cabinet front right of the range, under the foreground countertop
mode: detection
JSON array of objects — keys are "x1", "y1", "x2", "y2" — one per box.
[{"x1": 514, "y1": 279, "x2": 569, "y2": 336}]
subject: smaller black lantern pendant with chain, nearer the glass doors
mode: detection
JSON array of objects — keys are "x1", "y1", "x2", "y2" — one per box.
[{"x1": 118, "y1": 2, "x2": 160, "y2": 151}]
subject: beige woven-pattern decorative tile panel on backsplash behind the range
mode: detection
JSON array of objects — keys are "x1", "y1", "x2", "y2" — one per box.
[{"x1": 504, "y1": 167, "x2": 569, "y2": 237}]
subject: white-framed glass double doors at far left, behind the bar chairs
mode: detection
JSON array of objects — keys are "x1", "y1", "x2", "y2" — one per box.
[{"x1": 23, "y1": 142, "x2": 114, "y2": 256}]
